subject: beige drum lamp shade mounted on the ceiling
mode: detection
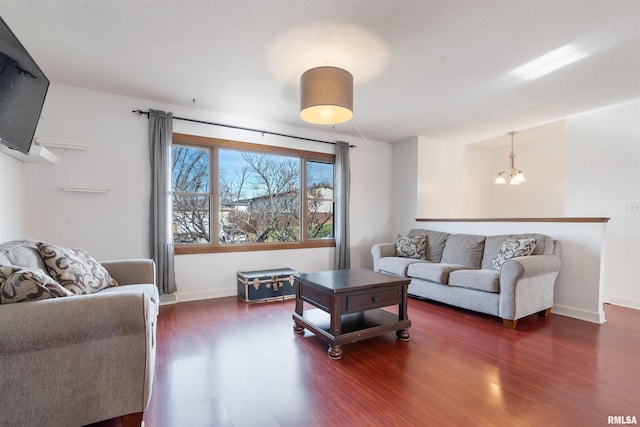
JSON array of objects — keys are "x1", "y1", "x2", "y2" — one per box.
[{"x1": 300, "y1": 67, "x2": 353, "y2": 125}]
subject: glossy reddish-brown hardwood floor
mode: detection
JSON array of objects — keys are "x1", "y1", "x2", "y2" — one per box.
[{"x1": 95, "y1": 297, "x2": 640, "y2": 427}]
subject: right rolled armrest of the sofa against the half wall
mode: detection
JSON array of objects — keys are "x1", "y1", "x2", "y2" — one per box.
[{"x1": 499, "y1": 255, "x2": 562, "y2": 320}]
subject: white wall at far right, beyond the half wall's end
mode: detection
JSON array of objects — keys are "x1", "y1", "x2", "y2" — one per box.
[{"x1": 565, "y1": 101, "x2": 640, "y2": 309}]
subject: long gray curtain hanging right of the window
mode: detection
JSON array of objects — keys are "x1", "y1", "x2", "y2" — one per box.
[{"x1": 334, "y1": 141, "x2": 351, "y2": 270}]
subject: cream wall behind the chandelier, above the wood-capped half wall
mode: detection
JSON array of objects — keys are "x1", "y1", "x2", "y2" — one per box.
[{"x1": 412, "y1": 121, "x2": 565, "y2": 218}]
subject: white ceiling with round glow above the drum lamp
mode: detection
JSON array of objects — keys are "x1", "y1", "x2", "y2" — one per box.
[{"x1": 0, "y1": 0, "x2": 640, "y2": 143}]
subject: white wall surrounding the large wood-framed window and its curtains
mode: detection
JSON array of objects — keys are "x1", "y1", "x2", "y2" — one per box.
[{"x1": 0, "y1": 84, "x2": 391, "y2": 300}]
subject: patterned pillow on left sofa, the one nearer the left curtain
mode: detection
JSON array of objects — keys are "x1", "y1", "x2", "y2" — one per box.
[{"x1": 36, "y1": 242, "x2": 118, "y2": 295}]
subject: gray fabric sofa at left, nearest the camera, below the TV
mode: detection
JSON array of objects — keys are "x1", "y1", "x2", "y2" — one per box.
[{"x1": 0, "y1": 240, "x2": 159, "y2": 426}]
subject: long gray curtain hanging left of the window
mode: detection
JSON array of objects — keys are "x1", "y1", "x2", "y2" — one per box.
[{"x1": 149, "y1": 109, "x2": 176, "y2": 295}]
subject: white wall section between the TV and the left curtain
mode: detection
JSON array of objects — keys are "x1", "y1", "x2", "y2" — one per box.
[{"x1": 15, "y1": 85, "x2": 150, "y2": 259}]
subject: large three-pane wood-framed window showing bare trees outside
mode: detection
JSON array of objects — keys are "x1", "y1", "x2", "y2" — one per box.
[{"x1": 171, "y1": 134, "x2": 335, "y2": 254}]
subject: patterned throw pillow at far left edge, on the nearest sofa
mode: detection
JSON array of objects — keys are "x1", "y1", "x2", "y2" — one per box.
[{"x1": 0, "y1": 265, "x2": 73, "y2": 304}]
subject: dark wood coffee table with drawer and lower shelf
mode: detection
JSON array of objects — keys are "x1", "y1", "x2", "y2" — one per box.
[{"x1": 293, "y1": 269, "x2": 411, "y2": 359}]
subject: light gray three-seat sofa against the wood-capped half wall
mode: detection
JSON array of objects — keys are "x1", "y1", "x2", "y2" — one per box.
[{"x1": 371, "y1": 229, "x2": 561, "y2": 328}]
